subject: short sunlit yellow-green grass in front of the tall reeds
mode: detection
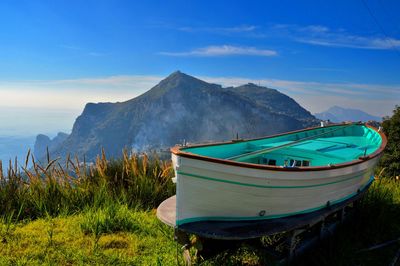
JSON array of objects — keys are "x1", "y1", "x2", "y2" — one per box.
[{"x1": 0, "y1": 210, "x2": 182, "y2": 265}]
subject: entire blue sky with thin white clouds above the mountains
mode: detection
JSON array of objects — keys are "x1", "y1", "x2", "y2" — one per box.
[{"x1": 0, "y1": 0, "x2": 400, "y2": 135}]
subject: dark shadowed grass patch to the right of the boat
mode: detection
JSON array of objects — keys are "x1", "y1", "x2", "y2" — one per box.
[{"x1": 298, "y1": 178, "x2": 400, "y2": 265}]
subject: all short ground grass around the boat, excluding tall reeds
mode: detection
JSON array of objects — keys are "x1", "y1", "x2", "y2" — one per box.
[{"x1": 0, "y1": 179, "x2": 400, "y2": 265}]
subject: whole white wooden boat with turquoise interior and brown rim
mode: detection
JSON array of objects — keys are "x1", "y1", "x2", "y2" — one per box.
[{"x1": 168, "y1": 123, "x2": 387, "y2": 229}]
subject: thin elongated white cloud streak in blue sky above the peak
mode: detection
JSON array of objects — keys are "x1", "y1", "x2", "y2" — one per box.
[{"x1": 159, "y1": 45, "x2": 278, "y2": 57}]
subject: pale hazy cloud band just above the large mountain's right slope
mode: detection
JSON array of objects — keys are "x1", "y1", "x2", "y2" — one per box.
[{"x1": 200, "y1": 77, "x2": 400, "y2": 116}]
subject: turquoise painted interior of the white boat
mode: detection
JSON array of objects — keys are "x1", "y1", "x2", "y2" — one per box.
[{"x1": 180, "y1": 124, "x2": 383, "y2": 167}]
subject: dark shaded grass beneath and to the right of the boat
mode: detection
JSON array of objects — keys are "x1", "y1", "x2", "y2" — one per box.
[{"x1": 195, "y1": 178, "x2": 400, "y2": 266}]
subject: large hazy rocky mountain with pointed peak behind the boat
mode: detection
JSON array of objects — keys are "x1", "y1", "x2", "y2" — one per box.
[{"x1": 37, "y1": 71, "x2": 318, "y2": 160}]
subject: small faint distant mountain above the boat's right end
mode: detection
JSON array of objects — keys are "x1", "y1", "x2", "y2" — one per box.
[{"x1": 315, "y1": 106, "x2": 382, "y2": 123}]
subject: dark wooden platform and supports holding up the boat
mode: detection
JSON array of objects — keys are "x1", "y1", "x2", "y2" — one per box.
[{"x1": 157, "y1": 180, "x2": 368, "y2": 264}]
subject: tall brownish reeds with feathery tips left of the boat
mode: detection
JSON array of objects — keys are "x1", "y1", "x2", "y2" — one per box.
[{"x1": 0, "y1": 150, "x2": 175, "y2": 219}]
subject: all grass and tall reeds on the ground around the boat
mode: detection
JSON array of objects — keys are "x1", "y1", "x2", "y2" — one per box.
[{"x1": 0, "y1": 151, "x2": 400, "y2": 265}]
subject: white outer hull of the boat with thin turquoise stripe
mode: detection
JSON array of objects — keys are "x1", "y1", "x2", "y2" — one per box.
[{"x1": 172, "y1": 154, "x2": 379, "y2": 227}]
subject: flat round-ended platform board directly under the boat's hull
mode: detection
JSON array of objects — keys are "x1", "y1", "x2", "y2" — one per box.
[{"x1": 157, "y1": 181, "x2": 369, "y2": 240}]
